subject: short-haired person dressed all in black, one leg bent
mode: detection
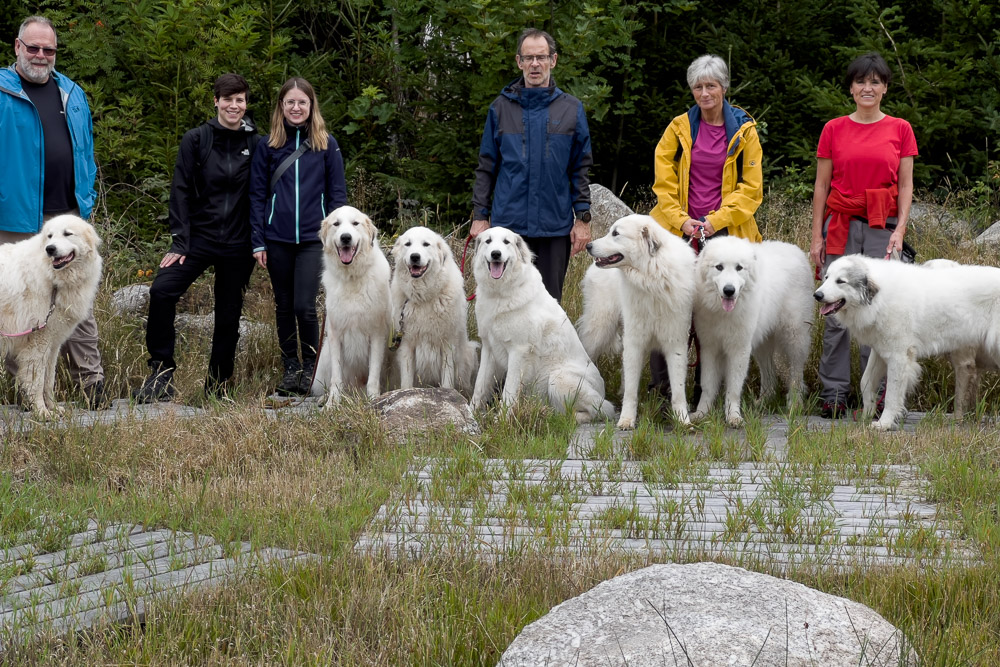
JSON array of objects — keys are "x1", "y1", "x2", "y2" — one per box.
[{"x1": 132, "y1": 74, "x2": 260, "y2": 403}]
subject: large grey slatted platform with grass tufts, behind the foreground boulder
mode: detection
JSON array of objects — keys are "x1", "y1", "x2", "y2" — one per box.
[{"x1": 356, "y1": 413, "x2": 974, "y2": 569}]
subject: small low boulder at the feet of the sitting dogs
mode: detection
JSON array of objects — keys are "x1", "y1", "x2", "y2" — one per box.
[{"x1": 373, "y1": 387, "x2": 480, "y2": 443}]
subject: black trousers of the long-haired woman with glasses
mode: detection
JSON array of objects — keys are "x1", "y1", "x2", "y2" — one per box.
[{"x1": 267, "y1": 241, "x2": 323, "y2": 363}]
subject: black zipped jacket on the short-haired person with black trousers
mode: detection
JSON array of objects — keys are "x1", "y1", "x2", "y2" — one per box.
[{"x1": 170, "y1": 118, "x2": 260, "y2": 255}]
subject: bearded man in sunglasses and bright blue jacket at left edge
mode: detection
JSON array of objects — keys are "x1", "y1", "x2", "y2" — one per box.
[{"x1": 0, "y1": 16, "x2": 104, "y2": 408}]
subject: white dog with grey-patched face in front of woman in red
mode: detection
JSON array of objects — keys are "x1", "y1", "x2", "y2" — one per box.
[{"x1": 814, "y1": 255, "x2": 1000, "y2": 431}]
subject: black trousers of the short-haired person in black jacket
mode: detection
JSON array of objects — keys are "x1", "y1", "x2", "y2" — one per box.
[{"x1": 146, "y1": 249, "x2": 254, "y2": 382}]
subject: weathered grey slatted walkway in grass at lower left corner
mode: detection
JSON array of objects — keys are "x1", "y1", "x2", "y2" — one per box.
[{"x1": 0, "y1": 522, "x2": 316, "y2": 652}]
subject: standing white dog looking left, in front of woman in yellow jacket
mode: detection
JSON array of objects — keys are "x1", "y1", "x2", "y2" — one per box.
[{"x1": 580, "y1": 215, "x2": 695, "y2": 429}]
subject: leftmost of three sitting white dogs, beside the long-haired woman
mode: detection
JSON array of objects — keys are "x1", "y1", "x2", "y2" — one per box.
[{"x1": 310, "y1": 206, "x2": 392, "y2": 407}]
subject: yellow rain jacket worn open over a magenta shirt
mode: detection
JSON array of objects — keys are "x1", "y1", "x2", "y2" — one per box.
[{"x1": 649, "y1": 102, "x2": 764, "y2": 243}]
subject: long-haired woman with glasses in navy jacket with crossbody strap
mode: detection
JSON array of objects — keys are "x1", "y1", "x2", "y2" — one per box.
[{"x1": 250, "y1": 77, "x2": 347, "y2": 395}]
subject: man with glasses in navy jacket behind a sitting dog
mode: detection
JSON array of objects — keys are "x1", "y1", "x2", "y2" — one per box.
[{"x1": 470, "y1": 28, "x2": 594, "y2": 299}]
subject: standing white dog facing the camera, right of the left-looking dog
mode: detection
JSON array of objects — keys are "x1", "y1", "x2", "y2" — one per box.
[{"x1": 691, "y1": 236, "x2": 815, "y2": 428}]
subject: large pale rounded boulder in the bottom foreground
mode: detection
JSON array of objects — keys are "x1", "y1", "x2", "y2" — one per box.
[{"x1": 499, "y1": 563, "x2": 917, "y2": 667}]
